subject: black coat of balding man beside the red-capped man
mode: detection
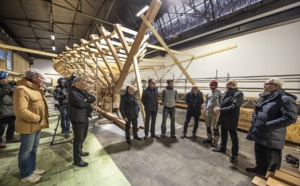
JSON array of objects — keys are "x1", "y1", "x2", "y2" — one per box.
[{"x1": 218, "y1": 88, "x2": 244, "y2": 130}]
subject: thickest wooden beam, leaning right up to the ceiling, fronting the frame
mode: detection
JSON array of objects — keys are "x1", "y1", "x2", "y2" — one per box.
[{"x1": 114, "y1": 0, "x2": 161, "y2": 93}]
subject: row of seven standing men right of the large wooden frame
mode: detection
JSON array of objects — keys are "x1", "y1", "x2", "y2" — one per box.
[{"x1": 120, "y1": 78, "x2": 297, "y2": 175}]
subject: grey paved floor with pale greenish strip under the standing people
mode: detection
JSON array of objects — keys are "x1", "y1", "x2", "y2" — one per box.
[{"x1": 0, "y1": 99, "x2": 299, "y2": 186}]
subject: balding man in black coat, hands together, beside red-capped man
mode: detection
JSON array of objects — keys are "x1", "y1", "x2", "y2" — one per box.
[{"x1": 213, "y1": 80, "x2": 244, "y2": 162}]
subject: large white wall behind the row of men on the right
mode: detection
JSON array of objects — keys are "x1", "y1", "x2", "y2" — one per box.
[{"x1": 127, "y1": 22, "x2": 300, "y2": 97}]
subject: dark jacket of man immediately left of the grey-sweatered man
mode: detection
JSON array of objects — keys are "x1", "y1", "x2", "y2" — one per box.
[{"x1": 142, "y1": 87, "x2": 158, "y2": 112}]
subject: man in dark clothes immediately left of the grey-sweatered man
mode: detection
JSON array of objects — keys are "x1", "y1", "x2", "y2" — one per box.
[{"x1": 142, "y1": 79, "x2": 158, "y2": 140}]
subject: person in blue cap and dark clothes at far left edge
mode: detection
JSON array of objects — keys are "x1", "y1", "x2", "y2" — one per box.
[{"x1": 0, "y1": 71, "x2": 20, "y2": 148}]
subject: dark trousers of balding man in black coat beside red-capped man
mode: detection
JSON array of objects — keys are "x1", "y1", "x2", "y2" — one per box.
[{"x1": 220, "y1": 127, "x2": 239, "y2": 156}]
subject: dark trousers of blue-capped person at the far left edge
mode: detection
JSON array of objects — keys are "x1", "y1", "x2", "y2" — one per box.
[{"x1": 0, "y1": 116, "x2": 16, "y2": 143}]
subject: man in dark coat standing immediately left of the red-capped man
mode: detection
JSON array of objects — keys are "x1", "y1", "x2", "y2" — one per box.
[{"x1": 181, "y1": 85, "x2": 203, "y2": 139}]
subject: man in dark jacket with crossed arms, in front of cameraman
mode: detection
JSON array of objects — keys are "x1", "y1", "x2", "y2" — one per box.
[{"x1": 68, "y1": 78, "x2": 96, "y2": 167}]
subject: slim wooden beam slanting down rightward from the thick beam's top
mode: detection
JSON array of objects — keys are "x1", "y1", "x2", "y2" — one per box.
[{"x1": 140, "y1": 14, "x2": 196, "y2": 85}]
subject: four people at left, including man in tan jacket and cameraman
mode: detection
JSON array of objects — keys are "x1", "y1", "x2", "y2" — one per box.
[{"x1": 0, "y1": 68, "x2": 96, "y2": 183}]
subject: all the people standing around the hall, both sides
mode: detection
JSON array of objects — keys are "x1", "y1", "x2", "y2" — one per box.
[{"x1": 0, "y1": 68, "x2": 297, "y2": 183}]
